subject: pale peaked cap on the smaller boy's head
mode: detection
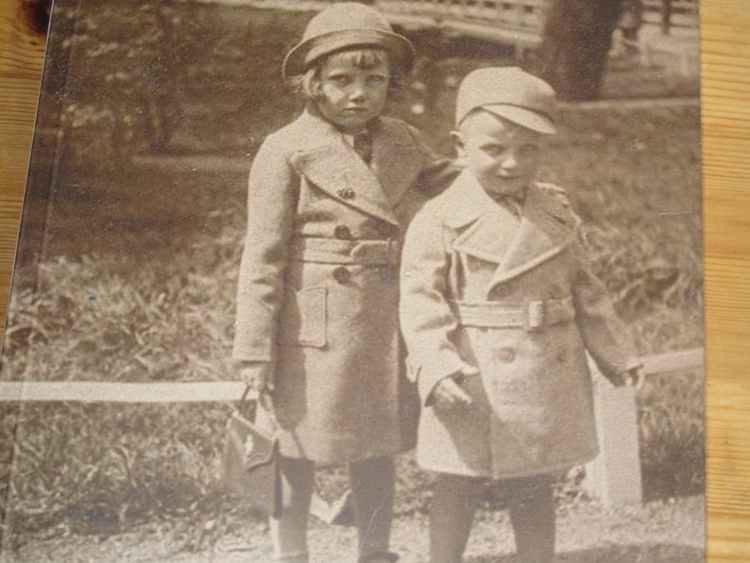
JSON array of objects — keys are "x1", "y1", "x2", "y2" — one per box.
[{"x1": 456, "y1": 67, "x2": 555, "y2": 134}]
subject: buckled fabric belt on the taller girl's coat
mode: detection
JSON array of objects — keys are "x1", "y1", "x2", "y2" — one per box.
[{"x1": 291, "y1": 237, "x2": 401, "y2": 266}]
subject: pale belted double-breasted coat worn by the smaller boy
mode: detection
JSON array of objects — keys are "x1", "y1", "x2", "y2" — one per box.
[{"x1": 401, "y1": 172, "x2": 638, "y2": 479}]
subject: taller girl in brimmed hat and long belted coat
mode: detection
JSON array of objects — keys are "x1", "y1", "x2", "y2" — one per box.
[{"x1": 234, "y1": 3, "x2": 455, "y2": 563}]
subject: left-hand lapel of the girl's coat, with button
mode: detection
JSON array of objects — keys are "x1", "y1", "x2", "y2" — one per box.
[{"x1": 292, "y1": 113, "x2": 398, "y2": 225}]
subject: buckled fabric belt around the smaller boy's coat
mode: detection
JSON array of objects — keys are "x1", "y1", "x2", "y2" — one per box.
[{"x1": 450, "y1": 297, "x2": 575, "y2": 330}]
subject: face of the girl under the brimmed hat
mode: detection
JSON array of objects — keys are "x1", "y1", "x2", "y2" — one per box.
[{"x1": 317, "y1": 57, "x2": 389, "y2": 133}]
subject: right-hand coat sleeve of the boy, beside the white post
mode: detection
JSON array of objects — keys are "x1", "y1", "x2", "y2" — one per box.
[{"x1": 573, "y1": 238, "x2": 642, "y2": 385}]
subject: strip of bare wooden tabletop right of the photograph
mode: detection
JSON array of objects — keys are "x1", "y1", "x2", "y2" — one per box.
[{"x1": 701, "y1": 0, "x2": 750, "y2": 562}]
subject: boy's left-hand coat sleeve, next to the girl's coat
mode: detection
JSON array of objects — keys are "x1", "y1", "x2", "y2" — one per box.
[{"x1": 400, "y1": 205, "x2": 478, "y2": 403}]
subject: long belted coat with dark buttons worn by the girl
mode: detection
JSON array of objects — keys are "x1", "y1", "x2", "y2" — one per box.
[{"x1": 233, "y1": 112, "x2": 456, "y2": 462}]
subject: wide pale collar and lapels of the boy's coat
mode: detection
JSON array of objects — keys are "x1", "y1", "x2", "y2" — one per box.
[{"x1": 445, "y1": 171, "x2": 576, "y2": 293}]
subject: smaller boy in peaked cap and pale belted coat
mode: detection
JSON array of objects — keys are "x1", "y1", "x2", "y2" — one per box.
[{"x1": 401, "y1": 68, "x2": 642, "y2": 563}]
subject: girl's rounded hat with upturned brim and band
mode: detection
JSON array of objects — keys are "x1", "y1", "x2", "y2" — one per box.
[{"x1": 282, "y1": 2, "x2": 414, "y2": 78}]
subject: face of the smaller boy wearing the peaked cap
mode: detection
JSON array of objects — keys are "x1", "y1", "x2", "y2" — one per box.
[{"x1": 452, "y1": 110, "x2": 545, "y2": 197}]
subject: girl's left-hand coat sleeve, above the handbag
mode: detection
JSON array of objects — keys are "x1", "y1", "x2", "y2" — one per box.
[{"x1": 232, "y1": 136, "x2": 299, "y2": 361}]
